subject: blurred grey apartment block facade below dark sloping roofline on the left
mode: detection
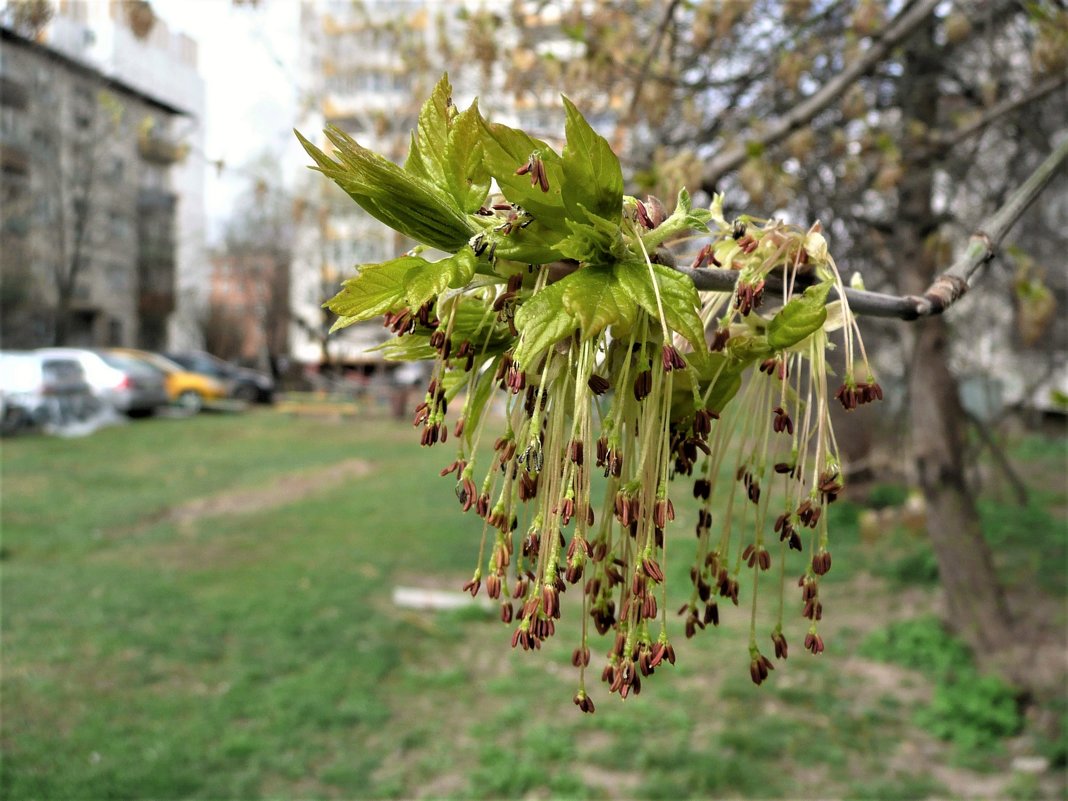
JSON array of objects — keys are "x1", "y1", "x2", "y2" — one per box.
[{"x1": 0, "y1": 28, "x2": 188, "y2": 349}]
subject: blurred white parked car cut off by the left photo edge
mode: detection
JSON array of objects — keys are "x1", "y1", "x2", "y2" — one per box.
[{"x1": 0, "y1": 351, "x2": 100, "y2": 434}]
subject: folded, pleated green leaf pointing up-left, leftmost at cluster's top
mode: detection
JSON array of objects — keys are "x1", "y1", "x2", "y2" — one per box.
[{"x1": 297, "y1": 127, "x2": 477, "y2": 253}]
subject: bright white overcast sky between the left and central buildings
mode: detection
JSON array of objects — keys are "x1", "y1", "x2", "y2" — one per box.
[{"x1": 152, "y1": 0, "x2": 304, "y2": 236}]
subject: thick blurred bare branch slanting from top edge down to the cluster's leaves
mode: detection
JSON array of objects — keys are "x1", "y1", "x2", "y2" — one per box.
[{"x1": 701, "y1": 0, "x2": 939, "y2": 194}]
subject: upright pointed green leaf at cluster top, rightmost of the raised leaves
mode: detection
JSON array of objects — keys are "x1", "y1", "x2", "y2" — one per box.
[{"x1": 561, "y1": 97, "x2": 623, "y2": 226}]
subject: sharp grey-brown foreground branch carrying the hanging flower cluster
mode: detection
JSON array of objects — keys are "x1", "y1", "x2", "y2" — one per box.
[{"x1": 675, "y1": 130, "x2": 1068, "y2": 320}]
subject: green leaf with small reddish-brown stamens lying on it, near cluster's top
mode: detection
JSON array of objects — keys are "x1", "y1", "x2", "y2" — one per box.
[{"x1": 480, "y1": 115, "x2": 567, "y2": 236}]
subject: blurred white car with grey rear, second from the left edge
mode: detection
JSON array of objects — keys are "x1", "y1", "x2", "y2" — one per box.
[{"x1": 35, "y1": 348, "x2": 169, "y2": 417}]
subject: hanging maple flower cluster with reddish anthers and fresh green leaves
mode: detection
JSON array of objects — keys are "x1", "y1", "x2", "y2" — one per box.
[{"x1": 302, "y1": 78, "x2": 882, "y2": 712}]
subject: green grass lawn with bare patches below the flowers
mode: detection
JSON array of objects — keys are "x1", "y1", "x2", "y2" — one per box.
[{"x1": 0, "y1": 411, "x2": 1068, "y2": 799}]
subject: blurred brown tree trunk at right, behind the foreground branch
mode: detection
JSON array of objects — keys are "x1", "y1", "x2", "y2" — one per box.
[{"x1": 896, "y1": 21, "x2": 1025, "y2": 682}]
